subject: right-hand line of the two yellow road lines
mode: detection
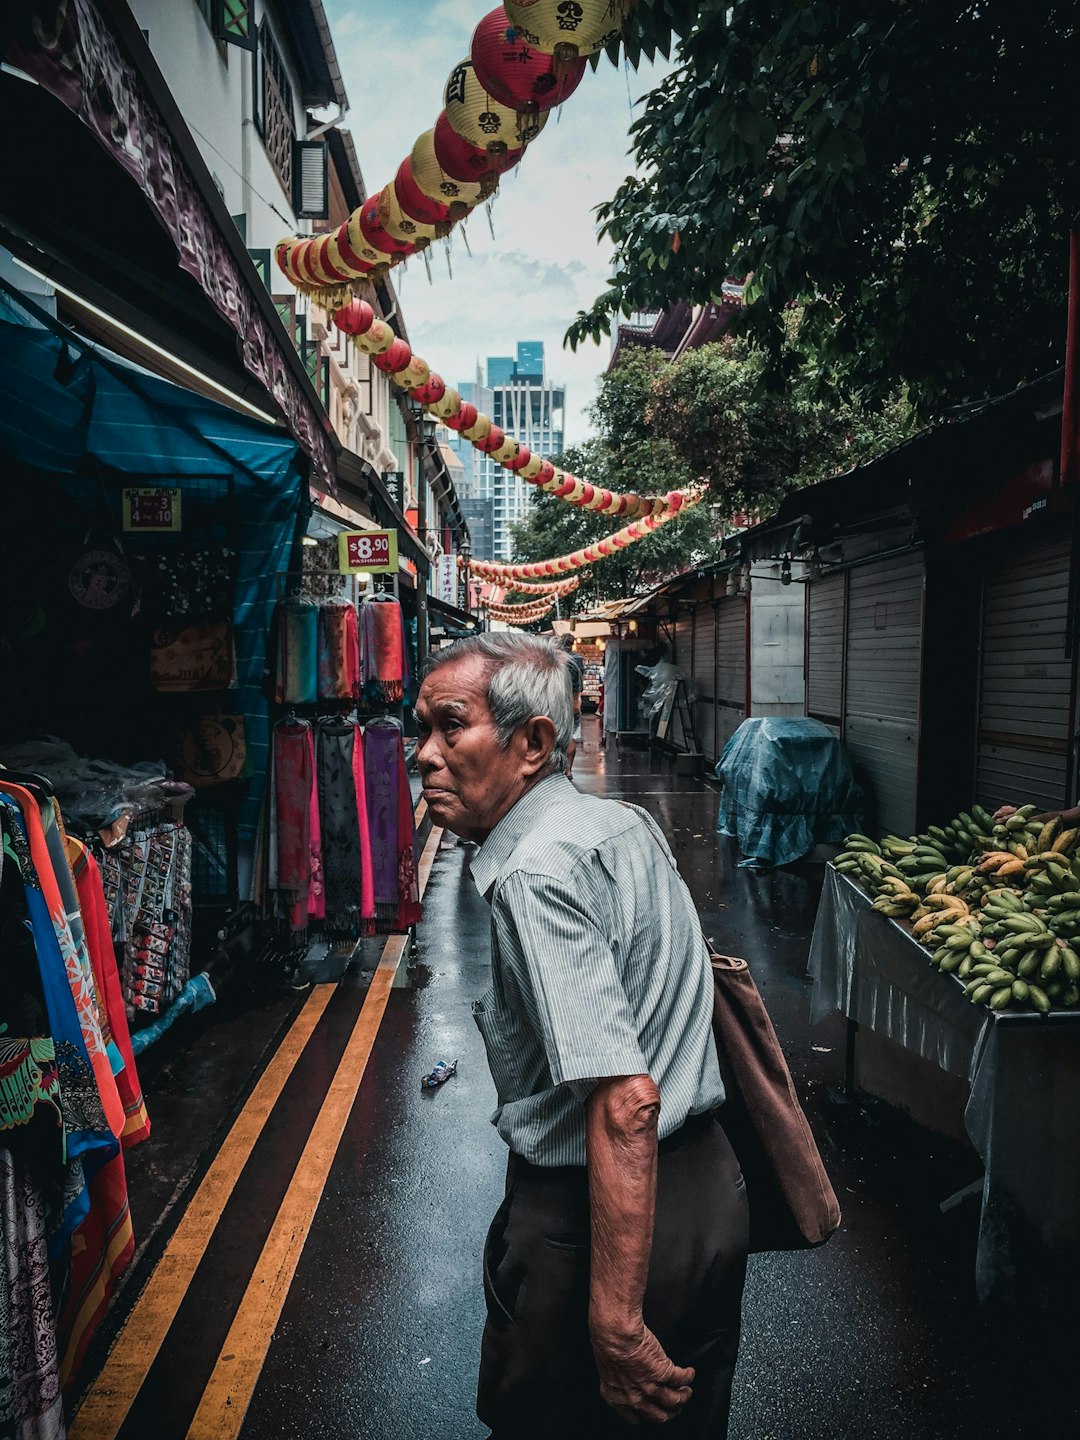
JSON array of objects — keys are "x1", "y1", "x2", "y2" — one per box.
[{"x1": 187, "y1": 828, "x2": 442, "y2": 1440}]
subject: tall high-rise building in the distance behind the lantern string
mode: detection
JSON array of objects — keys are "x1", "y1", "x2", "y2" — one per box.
[{"x1": 458, "y1": 340, "x2": 566, "y2": 560}]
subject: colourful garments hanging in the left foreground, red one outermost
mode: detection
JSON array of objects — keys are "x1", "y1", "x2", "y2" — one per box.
[{"x1": 0, "y1": 769, "x2": 150, "y2": 1411}]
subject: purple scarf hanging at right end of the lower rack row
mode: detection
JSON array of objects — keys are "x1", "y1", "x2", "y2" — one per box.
[{"x1": 364, "y1": 721, "x2": 420, "y2": 930}]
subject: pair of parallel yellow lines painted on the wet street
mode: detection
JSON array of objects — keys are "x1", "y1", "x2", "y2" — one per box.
[{"x1": 68, "y1": 802, "x2": 442, "y2": 1440}]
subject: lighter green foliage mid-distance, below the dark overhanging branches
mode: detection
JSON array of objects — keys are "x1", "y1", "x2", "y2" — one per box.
[{"x1": 514, "y1": 338, "x2": 912, "y2": 609}]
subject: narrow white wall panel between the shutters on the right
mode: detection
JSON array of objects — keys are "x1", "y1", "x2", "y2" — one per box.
[{"x1": 750, "y1": 563, "x2": 806, "y2": 716}]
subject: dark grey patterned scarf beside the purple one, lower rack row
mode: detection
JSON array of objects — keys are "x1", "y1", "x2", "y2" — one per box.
[{"x1": 317, "y1": 717, "x2": 374, "y2": 936}]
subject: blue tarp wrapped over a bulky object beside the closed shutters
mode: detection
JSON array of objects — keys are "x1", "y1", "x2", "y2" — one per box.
[{"x1": 716, "y1": 717, "x2": 864, "y2": 867}]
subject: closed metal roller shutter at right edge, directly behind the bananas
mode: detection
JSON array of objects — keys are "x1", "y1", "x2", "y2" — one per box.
[{"x1": 975, "y1": 540, "x2": 1076, "y2": 811}]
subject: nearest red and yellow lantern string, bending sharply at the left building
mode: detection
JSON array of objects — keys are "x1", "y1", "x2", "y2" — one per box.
[{"x1": 275, "y1": 0, "x2": 694, "y2": 520}]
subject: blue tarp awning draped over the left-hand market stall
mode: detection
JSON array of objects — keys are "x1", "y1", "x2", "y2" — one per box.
[{"x1": 0, "y1": 323, "x2": 305, "y2": 837}]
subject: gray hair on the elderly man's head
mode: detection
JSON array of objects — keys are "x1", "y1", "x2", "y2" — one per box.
[{"x1": 425, "y1": 631, "x2": 573, "y2": 775}]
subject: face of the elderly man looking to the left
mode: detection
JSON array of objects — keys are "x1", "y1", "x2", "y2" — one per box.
[{"x1": 416, "y1": 657, "x2": 531, "y2": 841}]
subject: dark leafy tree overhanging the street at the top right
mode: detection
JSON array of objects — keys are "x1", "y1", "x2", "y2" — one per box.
[{"x1": 567, "y1": 0, "x2": 1080, "y2": 413}]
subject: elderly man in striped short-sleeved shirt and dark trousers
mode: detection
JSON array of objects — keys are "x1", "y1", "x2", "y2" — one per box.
[{"x1": 416, "y1": 634, "x2": 747, "y2": 1440}]
